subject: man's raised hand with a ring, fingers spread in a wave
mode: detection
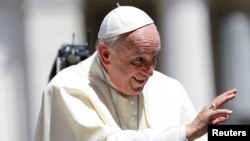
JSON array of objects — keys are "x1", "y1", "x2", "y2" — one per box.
[{"x1": 186, "y1": 89, "x2": 237, "y2": 141}]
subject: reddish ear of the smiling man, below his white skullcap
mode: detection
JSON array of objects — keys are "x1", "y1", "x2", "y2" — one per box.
[{"x1": 98, "y1": 43, "x2": 110, "y2": 66}]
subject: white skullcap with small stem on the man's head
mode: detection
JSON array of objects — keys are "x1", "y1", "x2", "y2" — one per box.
[{"x1": 98, "y1": 6, "x2": 154, "y2": 39}]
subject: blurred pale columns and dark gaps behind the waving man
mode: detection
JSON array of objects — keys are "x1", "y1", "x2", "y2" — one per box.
[{"x1": 0, "y1": 0, "x2": 250, "y2": 141}]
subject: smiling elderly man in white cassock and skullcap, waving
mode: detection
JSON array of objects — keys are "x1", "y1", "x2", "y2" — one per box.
[{"x1": 35, "y1": 6, "x2": 236, "y2": 141}]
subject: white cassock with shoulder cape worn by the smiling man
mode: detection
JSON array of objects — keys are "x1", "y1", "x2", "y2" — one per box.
[{"x1": 35, "y1": 52, "x2": 206, "y2": 141}]
